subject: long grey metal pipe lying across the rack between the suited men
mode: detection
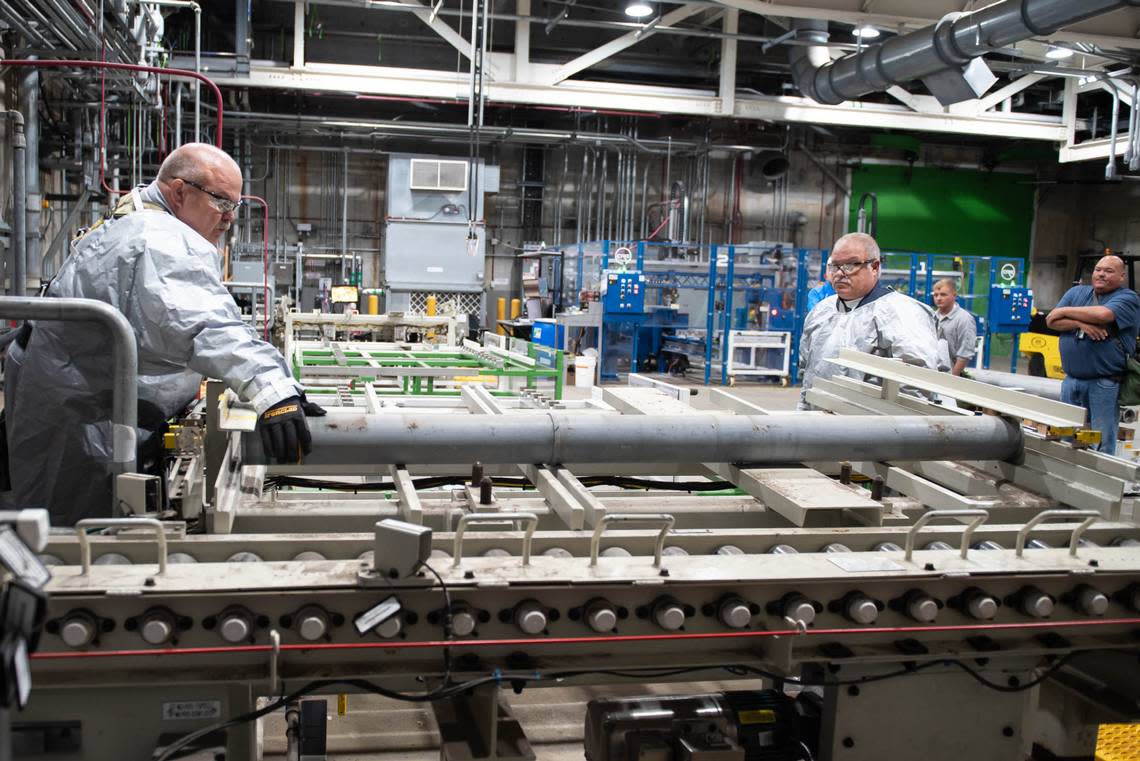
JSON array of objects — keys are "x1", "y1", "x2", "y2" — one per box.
[{"x1": 287, "y1": 411, "x2": 1021, "y2": 465}]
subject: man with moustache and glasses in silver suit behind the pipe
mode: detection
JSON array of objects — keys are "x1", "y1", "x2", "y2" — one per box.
[{"x1": 798, "y1": 232, "x2": 938, "y2": 410}]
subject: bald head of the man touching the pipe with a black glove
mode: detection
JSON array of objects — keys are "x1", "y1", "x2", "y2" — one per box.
[{"x1": 157, "y1": 142, "x2": 242, "y2": 245}]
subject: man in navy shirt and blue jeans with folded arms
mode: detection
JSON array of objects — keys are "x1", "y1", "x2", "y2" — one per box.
[{"x1": 1045, "y1": 256, "x2": 1140, "y2": 455}]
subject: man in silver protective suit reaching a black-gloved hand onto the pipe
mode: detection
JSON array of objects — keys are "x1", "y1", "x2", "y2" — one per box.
[{"x1": 3, "y1": 144, "x2": 324, "y2": 525}]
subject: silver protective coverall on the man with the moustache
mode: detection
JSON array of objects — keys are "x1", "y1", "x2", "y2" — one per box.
[{"x1": 798, "y1": 285, "x2": 938, "y2": 409}]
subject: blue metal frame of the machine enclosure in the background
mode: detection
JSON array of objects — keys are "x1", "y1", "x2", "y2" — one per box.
[{"x1": 565, "y1": 240, "x2": 1027, "y2": 385}]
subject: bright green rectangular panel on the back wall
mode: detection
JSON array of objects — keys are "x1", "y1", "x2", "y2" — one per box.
[{"x1": 849, "y1": 165, "x2": 1034, "y2": 257}]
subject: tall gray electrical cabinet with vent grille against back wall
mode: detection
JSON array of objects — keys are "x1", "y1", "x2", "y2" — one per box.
[{"x1": 383, "y1": 154, "x2": 499, "y2": 314}]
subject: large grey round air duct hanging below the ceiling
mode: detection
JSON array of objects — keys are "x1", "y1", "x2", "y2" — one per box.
[{"x1": 790, "y1": 0, "x2": 1140, "y2": 106}]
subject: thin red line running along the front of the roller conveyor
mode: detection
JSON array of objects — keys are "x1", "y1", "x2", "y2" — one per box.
[{"x1": 32, "y1": 617, "x2": 1140, "y2": 661}]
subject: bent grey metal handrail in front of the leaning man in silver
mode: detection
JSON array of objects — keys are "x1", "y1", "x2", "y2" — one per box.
[{"x1": 0, "y1": 296, "x2": 139, "y2": 474}]
